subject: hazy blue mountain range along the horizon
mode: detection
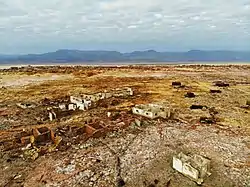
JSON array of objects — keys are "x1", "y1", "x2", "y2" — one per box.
[{"x1": 0, "y1": 49, "x2": 250, "y2": 64}]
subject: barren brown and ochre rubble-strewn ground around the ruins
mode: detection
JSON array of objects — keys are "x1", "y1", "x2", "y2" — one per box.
[{"x1": 0, "y1": 65, "x2": 250, "y2": 187}]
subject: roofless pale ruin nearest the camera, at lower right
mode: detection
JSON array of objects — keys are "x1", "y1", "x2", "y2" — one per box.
[{"x1": 173, "y1": 153, "x2": 211, "y2": 185}]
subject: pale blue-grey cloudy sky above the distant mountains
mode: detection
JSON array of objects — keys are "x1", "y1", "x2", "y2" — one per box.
[{"x1": 0, "y1": 0, "x2": 250, "y2": 54}]
